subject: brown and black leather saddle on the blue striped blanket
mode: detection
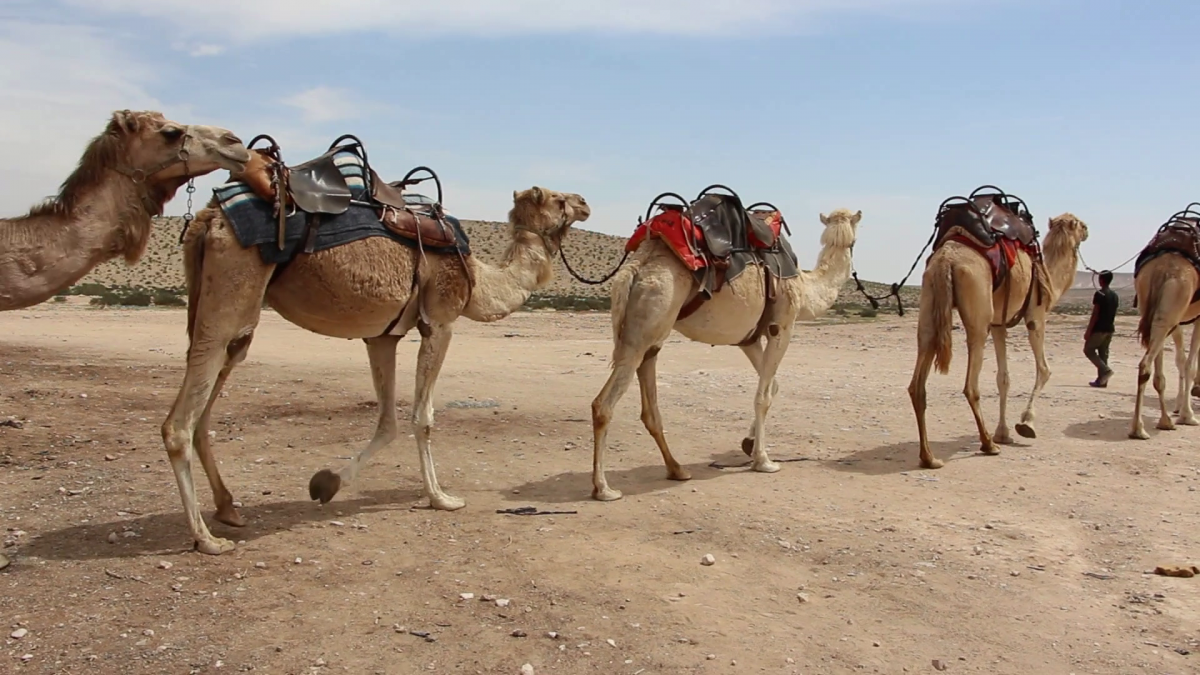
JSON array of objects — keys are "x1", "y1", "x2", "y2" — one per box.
[{"x1": 233, "y1": 133, "x2": 461, "y2": 255}]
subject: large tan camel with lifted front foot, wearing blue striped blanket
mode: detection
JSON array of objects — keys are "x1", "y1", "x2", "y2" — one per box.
[{"x1": 162, "y1": 187, "x2": 592, "y2": 555}]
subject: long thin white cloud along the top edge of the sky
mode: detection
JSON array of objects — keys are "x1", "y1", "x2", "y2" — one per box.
[{"x1": 61, "y1": 0, "x2": 996, "y2": 40}]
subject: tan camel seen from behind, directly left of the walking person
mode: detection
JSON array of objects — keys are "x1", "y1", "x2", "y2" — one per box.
[{"x1": 908, "y1": 214, "x2": 1087, "y2": 468}]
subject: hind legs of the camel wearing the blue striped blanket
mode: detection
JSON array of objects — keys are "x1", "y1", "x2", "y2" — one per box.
[{"x1": 162, "y1": 228, "x2": 274, "y2": 555}]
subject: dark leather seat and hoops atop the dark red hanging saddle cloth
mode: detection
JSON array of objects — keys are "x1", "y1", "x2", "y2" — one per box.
[{"x1": 935, "y1": 185, "x2": 1039, "y2": 250}]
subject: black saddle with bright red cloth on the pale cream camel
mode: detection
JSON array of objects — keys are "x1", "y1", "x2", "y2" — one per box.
[{"x1": 625, "y1": 185, "x2": 799, "y2": 345}]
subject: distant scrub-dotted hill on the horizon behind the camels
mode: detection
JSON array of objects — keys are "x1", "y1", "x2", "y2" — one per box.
[{"x1": 76, "y1": 216, "x2": 1104, "y2": 315}]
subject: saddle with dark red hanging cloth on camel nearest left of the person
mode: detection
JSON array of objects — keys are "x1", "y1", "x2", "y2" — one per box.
[{"x1": 925, "y1": 185, "x2": 1044, "y2": 328}]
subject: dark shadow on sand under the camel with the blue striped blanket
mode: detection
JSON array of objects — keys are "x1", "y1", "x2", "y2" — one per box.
[{"x1": 20, "y1": 489, "x2": 420, "y2": 560}]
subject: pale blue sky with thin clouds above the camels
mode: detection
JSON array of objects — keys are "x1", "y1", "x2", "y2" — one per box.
[{"x1": 0, "y1": 0, "x2": 1200, "y2": 282}]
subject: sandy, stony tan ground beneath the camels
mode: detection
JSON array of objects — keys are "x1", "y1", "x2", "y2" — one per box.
[{"x1": 0, "y1": 301, "x2": 1200, "y2": 675}]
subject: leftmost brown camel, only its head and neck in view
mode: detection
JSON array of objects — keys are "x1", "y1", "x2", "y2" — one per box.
[{"x1": 0, "y1": 110, "x2": 250, "y2": 311}]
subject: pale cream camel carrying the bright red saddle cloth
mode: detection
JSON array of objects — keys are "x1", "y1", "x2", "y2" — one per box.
[{"x1": 592, "y1": 209, "x2": 863, "y2": 501}]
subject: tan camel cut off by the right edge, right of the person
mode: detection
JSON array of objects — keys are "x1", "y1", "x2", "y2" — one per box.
[{"x1": 1129, "y1": 253, "x2": 1200, "y2": 441}]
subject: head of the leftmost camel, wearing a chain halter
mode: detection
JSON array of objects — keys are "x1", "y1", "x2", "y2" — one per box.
[{"x1": 104, "y1": 110, "x2": 250, "y2": 183}]
